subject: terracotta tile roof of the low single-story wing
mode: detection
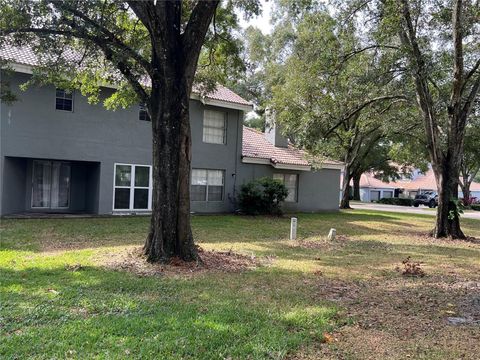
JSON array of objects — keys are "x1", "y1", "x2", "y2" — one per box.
[{"x1": 242, "y1": 126, "x2": 342, "y2": 166}]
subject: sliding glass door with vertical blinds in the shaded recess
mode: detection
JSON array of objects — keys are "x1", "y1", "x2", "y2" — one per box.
[{"x1": 32, "y1": 160, "x2": 70, "y2": 209}]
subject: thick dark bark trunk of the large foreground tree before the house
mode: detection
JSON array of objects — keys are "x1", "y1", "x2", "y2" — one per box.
[{"x1": 132, "y1": 1, "x2": 218, "y2": 262}]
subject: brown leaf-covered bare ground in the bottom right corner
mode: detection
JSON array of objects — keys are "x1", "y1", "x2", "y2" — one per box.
[{"x1": 304, "y1": 274, "x2": 480, "y2": 359}]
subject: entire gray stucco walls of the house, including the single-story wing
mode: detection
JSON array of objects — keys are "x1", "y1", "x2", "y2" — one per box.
[{"x1": 0, "y1": 73, "x2": 340, "y2": 214}]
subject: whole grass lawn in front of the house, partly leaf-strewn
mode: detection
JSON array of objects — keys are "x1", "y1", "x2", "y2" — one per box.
[{"x1": 0, "y1": 210, "x2": 480, "y2": 359}]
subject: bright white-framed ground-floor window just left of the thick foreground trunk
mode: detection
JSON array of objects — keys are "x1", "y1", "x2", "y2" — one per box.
[{"x1": 113, "y1": 164, "x2": 152, "y2": 210}]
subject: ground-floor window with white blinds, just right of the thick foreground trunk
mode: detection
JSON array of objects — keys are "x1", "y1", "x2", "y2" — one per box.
[{"x1": 190, "y1": 169, "x2": 225, "y2": 201}]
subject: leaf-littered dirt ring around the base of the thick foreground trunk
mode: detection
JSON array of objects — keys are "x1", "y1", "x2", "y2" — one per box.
[{"x1": 100, "y1": 247, "x2": 260, "y2": 276}]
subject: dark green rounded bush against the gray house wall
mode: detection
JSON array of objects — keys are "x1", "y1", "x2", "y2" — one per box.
[{"x1": 238, "y1": 177, "x2": 288, "y2": 215}]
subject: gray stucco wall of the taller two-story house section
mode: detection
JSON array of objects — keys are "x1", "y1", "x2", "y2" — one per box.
[{"x1": 0, "y1": 73, "x2": 243, "y2": 214}]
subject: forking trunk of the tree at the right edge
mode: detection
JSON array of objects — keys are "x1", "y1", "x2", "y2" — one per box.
[{"x1": 398, "y1": 0, "x2": 480, "y2": 239}]
